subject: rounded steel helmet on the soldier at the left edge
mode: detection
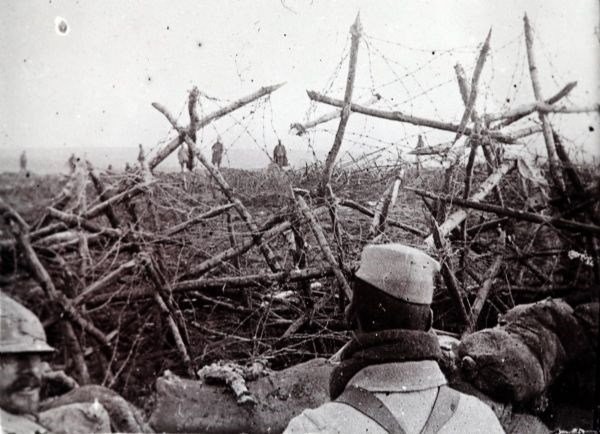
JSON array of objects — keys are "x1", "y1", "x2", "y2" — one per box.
[{"x1": 0, "y1": 293, "x2": 54, "y2": 354}]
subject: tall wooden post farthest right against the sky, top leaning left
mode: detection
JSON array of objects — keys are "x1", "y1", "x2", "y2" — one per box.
[{"x1": 523, "y1": 14, "x2": 565, "y2": 192}]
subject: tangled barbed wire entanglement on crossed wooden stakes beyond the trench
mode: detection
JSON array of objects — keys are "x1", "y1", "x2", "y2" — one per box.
[{"x1": 0, "y1": 13, "x2": 600, "y2": 416}]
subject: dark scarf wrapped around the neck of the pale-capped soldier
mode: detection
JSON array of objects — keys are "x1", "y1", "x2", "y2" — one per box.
[{"x1": 329, "y1": 330, "x2": 442, "y2": 400}]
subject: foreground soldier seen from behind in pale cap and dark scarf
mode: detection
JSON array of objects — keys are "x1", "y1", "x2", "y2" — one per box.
[{"x1": 285, "y1": 244, "x2": 504, "y2": 434}]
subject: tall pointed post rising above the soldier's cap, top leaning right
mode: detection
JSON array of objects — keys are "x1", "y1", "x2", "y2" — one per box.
[{"x1": 321, "y1": 14, "x2": 362, "y2": 193}]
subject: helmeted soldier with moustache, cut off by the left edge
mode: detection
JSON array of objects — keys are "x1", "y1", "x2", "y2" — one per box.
[{"x1": 0, "y1": 292, "x2": 110, "y2": 434}]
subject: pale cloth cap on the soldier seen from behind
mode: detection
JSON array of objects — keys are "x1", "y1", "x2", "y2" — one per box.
[{"x1": 356, "y1": 244, "x2": 440, "y2": 304}]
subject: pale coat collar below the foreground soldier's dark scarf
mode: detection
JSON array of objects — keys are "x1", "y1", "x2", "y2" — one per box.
[{"x1": 348, "y1": 360, "x2": 447, "y2": 392}]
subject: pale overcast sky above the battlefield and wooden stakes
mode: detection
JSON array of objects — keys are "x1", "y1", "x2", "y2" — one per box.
[{"x1": 0, "y1": 0, "x2": 600, "y2": 170}]
